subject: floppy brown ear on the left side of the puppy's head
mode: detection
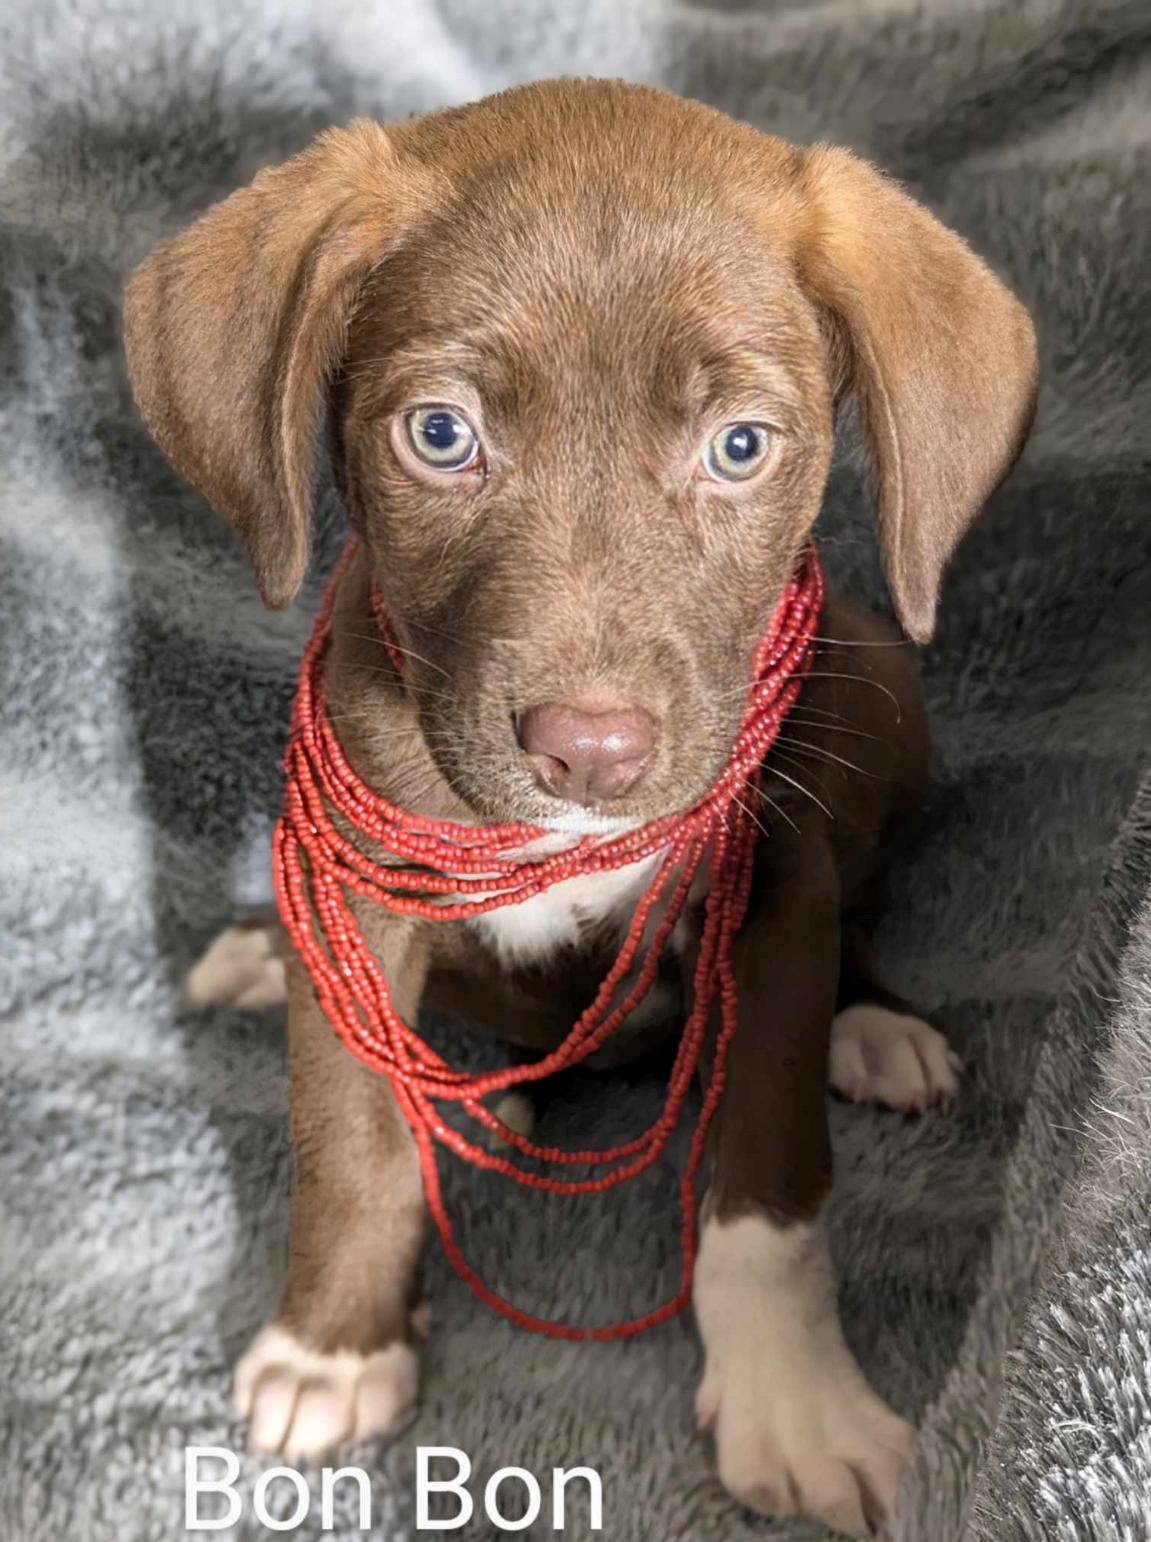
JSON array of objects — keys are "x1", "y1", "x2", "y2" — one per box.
[{"x1": 123, "y1": 120, "x2": 424, "y2": 611}]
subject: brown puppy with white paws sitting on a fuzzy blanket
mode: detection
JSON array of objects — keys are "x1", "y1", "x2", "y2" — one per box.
[{"x1": 127, "y1": 80, "x2": 1035, "y2": 1530}]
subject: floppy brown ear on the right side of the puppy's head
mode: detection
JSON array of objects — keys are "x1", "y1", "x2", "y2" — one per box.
[{"x1": 799, "y1": 145, "x2": 1037, "y2": 643}]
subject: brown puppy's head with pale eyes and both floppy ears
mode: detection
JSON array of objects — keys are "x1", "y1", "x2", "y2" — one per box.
[{"x1": 125, "y1": 82, "x2": 1035, "y2": 828}]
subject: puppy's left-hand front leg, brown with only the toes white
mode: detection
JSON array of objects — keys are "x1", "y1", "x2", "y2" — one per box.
[{"x1": 235, "y1": 924, "x2": 424, "y2": 1459}]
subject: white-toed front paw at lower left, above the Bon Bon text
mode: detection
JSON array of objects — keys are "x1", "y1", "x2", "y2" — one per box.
[{"x1": 233, "y1": 1323, "x2": 418, "y2": 1460}]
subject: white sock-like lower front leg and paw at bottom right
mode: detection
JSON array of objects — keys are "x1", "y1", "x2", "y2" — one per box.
[{"x1": 696, "y1": 1215, "x2": 915, "y2": 1534}]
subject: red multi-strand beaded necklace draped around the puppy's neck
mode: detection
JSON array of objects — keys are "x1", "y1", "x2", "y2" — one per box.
[{"x1": 273, "y1": 541, "x2": 824, "y2": 1338}]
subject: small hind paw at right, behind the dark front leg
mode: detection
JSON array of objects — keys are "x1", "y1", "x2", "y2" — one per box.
[{"x1": 829, "y1": 1002, "x2": 963, "y2": 1113}]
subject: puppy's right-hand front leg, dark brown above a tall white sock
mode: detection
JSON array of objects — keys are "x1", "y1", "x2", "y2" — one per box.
[{"x1": 694, "y1": 833, "x2": 913, "y2": 1533}]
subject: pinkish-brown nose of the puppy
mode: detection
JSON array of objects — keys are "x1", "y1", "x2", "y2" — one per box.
[{"x1": 517, "y1": 702, "x2": 656, "y2": 803}]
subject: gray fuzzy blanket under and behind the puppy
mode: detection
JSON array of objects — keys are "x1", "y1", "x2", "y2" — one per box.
[{"x1": 0, "y1": 0, "x2": 1151, "y2": 1542}]
